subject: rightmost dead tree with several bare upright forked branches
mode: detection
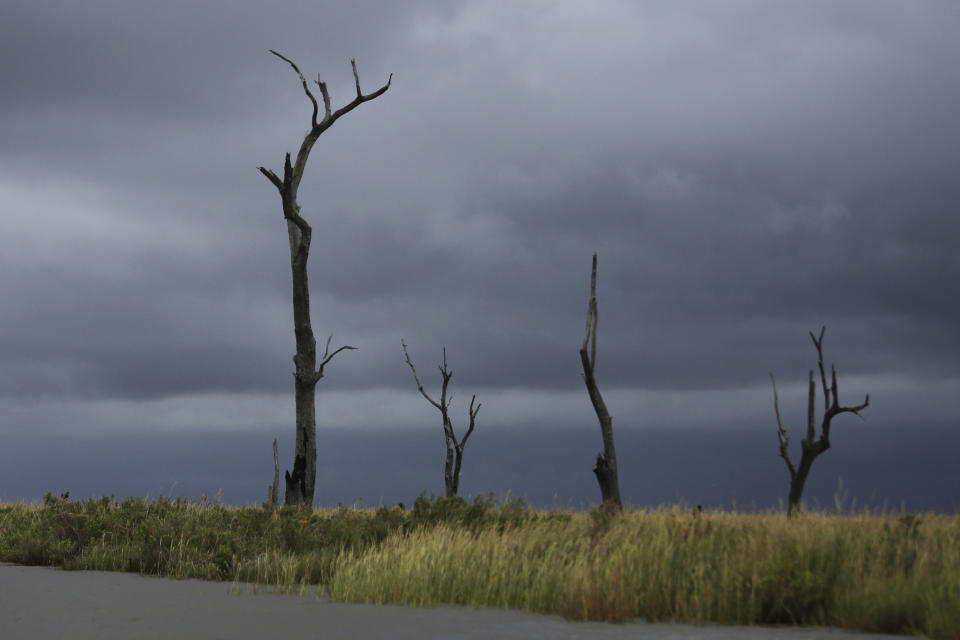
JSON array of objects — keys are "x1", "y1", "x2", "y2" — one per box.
[{"x1": 770, "y1": 327, "x2": 870, "y2": 516}]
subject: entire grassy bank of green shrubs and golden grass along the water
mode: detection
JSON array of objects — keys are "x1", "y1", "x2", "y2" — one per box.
[{"x1": 0, "y1": 498, "x2": 960, "y2": 638}]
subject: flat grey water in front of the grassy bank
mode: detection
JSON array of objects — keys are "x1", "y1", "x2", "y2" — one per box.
[{"x1": 0, "y1": 565, "x2": 899, "y2": 640}]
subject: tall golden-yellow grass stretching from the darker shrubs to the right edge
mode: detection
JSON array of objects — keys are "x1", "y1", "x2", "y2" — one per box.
[{"x1": 327, "y1": 509, "x2": 960, "y2": 638}]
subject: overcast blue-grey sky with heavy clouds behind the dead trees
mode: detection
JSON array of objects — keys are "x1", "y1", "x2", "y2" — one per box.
[{"x1": 0, "y1": 0, "x2": 960, "y2": 507}]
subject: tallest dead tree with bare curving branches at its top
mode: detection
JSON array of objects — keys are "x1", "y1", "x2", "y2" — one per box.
[{"x1": 258, "y1": 49, "x2": 393, "y2": 505}]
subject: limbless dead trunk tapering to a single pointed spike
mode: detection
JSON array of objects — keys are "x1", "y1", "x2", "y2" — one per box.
[{"x1": 580, "y1": 254, "x2": 623, "y2": 509}]
